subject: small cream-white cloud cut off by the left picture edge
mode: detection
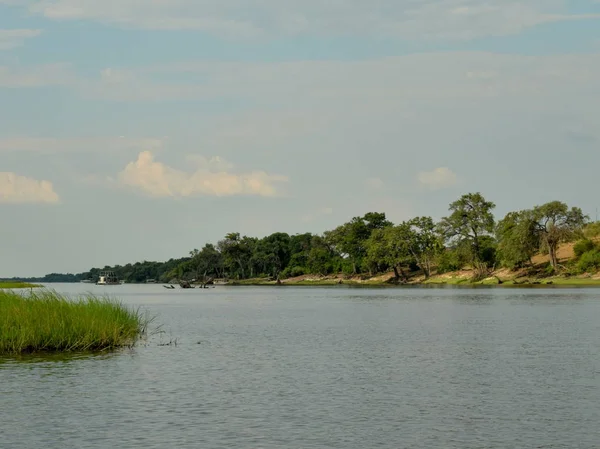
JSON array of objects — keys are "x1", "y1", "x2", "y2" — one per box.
[{"x1": 0, "y1": 172, "x2": 59, "y2": 203}]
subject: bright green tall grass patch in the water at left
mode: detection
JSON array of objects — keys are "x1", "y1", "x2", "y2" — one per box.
[{"x1": 0, "y1": 290, "x2": 148, "y2": 355}]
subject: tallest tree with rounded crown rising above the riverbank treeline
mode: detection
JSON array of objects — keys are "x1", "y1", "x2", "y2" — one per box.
[{"x1": 440, "y1": 193, "x2": 496, "y2": 264}]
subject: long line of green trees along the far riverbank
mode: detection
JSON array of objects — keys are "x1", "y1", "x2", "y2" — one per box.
[{"x1": 8, "y1": 193, "x2": 600, "y2": 283}]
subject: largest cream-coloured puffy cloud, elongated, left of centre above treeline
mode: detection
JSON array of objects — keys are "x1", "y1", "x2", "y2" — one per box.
[{"x1": 119, "y1": 151, "x2": 288, "y2": 198}]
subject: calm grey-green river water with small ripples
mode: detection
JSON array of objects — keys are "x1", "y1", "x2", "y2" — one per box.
[{"x1": 0, "y1": 284, "x2": 600, "y2": 449}]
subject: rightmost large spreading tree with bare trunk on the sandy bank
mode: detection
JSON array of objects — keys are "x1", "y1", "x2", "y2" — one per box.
[{"x1": 533, "y1": 201, "x2": 588, "y2": 271}]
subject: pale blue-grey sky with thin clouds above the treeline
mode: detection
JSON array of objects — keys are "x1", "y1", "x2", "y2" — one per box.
[{"x1": 0, "y1": 0, "x2": 600, "y2": 277}]
